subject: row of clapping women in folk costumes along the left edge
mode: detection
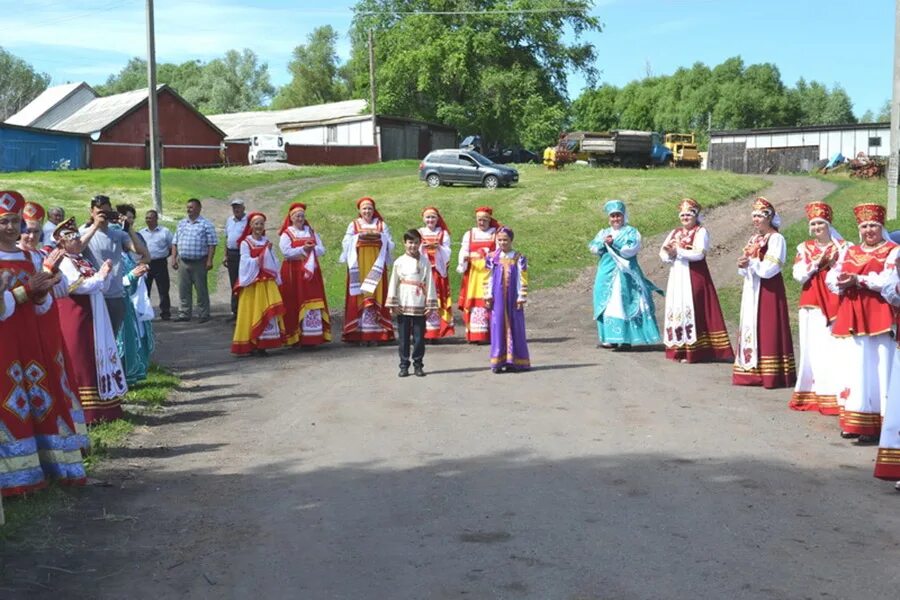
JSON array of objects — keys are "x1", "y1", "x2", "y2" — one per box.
[{"x1": 0, "y1": 191, "x2": 153, "y2": 496}]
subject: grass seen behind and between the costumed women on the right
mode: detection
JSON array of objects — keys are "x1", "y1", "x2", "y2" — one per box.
[{"x1": 719, "y1": 173, "x2": 900, "y2": 334}]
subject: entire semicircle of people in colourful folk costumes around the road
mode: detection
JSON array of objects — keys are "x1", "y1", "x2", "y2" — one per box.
[{"x1": 7, "y1": 192, "x2": 900, "y2": 502}]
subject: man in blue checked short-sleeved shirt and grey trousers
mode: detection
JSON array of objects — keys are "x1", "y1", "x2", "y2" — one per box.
[{"x1": 172, "y1": 198, "x2": 218, "y2": 323}]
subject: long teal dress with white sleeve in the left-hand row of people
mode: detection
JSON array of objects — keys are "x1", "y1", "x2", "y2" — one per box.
[{"x1": 116, "y1": 252, "x2": 153, "y2": 386}]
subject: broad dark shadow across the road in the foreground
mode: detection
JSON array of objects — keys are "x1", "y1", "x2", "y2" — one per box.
[{"x1": 0, "y1": 452, "x2": 900, "y2": 599}]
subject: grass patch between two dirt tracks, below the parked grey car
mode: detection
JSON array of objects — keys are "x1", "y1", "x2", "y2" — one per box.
[{"x1": 280, "y1": 165, "x2": 768, "y2": 310}]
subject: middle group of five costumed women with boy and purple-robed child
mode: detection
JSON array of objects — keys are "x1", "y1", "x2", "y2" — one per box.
[{"x1": 231, "y1": 197, "x2": 531, "y2": 377}]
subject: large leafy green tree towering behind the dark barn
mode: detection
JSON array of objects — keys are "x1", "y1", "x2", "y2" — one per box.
[{"x1": 349, "y1": 0, "x2": 600, "y2": 146}]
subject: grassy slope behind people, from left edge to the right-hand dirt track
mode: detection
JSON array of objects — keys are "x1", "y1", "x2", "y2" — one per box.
[{"x1": 0, "y1": 161, "x2": 767, "y2": 308}]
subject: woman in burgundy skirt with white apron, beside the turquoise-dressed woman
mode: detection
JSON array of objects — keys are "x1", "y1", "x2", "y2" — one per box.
[{"x1": 659, "y1": 198, "x2": 734, "y2": 363}]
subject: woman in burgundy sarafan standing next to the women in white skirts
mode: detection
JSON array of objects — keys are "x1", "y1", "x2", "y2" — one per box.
[{"x1": 731, "y1": 197, "x2": 797, "y2": 388}]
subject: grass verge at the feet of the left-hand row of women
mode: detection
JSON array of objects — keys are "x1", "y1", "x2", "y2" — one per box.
[{"x1": 0, "y1": 365, "x2": 181, "y2": 540}]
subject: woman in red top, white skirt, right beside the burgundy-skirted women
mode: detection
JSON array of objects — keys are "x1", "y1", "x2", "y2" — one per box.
[{"x1": 788, "y1": 202, "x2": 848, "y2": 415}]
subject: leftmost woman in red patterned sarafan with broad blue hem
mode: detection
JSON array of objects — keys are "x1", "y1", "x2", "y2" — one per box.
[{"x1": 0, "y1": 191, "x2": 86, "y2": 496}]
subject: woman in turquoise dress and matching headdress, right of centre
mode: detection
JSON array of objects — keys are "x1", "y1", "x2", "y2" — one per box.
[{"x1": 588, "y1": 200, "x2": 662, "y2": 349}]
